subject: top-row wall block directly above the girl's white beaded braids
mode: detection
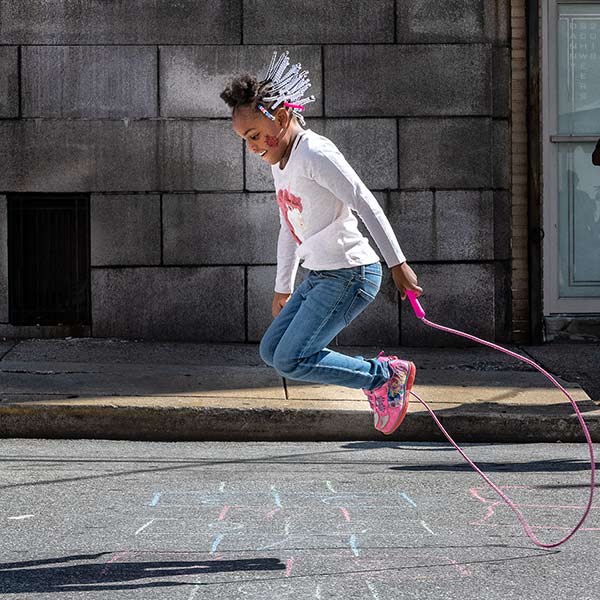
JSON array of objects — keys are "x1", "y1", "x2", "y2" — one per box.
[{"x1": 244, "y1": 0, "x2": 394, "y2": 47}]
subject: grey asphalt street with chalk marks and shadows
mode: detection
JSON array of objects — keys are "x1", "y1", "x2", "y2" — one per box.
[{"x1": 0, "y1": 439, "x2": 600, "y2": 600}]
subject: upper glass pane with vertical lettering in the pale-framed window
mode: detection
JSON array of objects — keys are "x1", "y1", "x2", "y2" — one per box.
[{"x1": 558, "y1": 4, "x2": 600, "y2": 134}]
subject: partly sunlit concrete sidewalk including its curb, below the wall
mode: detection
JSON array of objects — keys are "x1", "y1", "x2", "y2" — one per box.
[{"x1": 0, "y1": 338, "x2": 600, "y2": 442}]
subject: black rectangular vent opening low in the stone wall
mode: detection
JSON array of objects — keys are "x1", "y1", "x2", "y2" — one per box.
[{"x1": 7, "y1": 194, "x2": 90, "y2": 325}]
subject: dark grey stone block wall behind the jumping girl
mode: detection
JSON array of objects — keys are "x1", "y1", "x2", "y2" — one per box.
[{"x1": 0, "y1": 0, "x2": 511, "y2": 346}]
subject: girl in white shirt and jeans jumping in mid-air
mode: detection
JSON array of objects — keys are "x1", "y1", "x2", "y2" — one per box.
[{"x1": 220, "y1": 51, "x2": 423, "y2": 435}]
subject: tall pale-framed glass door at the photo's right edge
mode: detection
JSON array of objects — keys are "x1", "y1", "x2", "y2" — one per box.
[{"x1": 542, "y1": 0, "x2": 600, "y2": 315}]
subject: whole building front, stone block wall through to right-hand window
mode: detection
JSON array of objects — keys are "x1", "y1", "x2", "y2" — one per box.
[{"x1": 0, "y1": 0, "x2": 600, "y2": 346}]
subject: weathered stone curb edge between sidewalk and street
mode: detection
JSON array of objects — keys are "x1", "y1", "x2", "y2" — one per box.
[{"x1": 0, "y1": 404, "x2": 600, "y2": 443}]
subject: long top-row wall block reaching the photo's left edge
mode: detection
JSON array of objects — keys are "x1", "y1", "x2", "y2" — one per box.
[{"x1": 0, "y1": 0, "x2": 242, "y2": 45}]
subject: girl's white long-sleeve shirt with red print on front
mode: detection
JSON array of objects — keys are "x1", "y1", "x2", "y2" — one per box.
[{"x1": 271, "y1": 129, "x2": 406, "y2": 294}]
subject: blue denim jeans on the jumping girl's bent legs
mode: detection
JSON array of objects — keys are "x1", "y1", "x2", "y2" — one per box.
[{"x1": 260, "y1": 262, "x2": 390, "y2": 390}]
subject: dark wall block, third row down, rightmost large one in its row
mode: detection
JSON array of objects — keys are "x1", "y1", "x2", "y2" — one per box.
[{"x1": 398, "y1": 118, "x2": 493, "y2": 189}]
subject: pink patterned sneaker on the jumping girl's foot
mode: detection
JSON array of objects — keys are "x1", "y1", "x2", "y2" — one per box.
[{"x1": 363, "y1": 352, "x2": 417, "y2": 435}]
